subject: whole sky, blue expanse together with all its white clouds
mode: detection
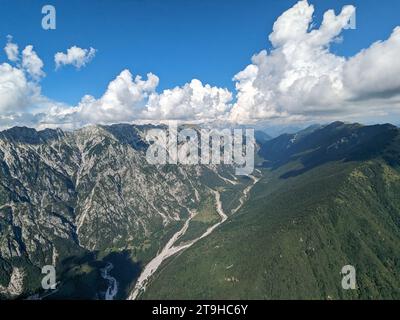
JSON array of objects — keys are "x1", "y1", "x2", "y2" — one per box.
[{"x1": 0, "y1": 0, "x2": 400, "y2": 128}]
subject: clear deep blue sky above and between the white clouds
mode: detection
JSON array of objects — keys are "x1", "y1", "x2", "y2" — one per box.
[{"x1": 0, "y1": 0, "x2": 400, "y2": 104}]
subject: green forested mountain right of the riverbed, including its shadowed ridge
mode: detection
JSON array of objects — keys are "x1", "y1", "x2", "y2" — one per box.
[{"x1": 142, "y1": 122, "x2": 400, "y2": 299}]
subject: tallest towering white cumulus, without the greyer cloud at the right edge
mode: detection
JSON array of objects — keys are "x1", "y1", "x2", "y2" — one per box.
[{"x1": 231, "y1": 0, "x2": 355, "y2": 122}]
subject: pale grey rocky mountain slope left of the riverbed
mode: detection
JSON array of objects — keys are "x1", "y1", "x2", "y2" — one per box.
[{"x1": 0, "y1": 124, "x2": 244, "y2": 298}]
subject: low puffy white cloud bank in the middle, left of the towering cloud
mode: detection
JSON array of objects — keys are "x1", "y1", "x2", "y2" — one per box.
[{"x1": 69, "y1": 70, "x2": 232, "y2": 124}]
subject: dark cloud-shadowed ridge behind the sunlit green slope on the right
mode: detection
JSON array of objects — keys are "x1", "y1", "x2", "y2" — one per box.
[{"x1": 260, "y1": 122, "x2": 400, "y2": 175}]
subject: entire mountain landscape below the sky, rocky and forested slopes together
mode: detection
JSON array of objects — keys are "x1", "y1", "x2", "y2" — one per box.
[{"x1": 0, "y1": 122, "x2": 400, "y2": 299}]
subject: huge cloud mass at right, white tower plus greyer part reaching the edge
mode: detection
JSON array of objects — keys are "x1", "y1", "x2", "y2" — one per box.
[{"x1": 230, "y1": 0, "x2": 400, "y2": 122}]
